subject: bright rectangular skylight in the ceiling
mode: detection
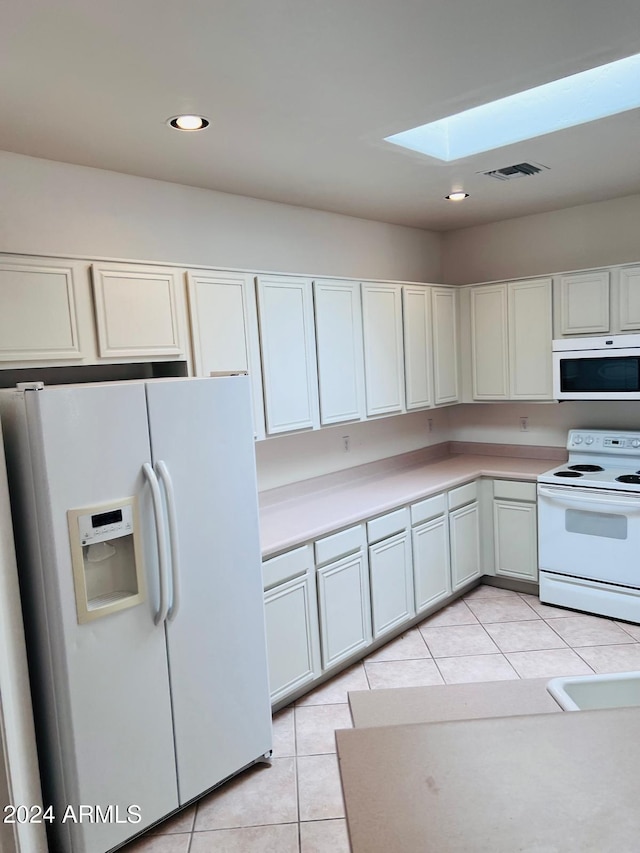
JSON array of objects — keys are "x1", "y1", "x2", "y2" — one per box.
[{"x1": 385, "y1": 54, "x2": 640, "y2": 161}]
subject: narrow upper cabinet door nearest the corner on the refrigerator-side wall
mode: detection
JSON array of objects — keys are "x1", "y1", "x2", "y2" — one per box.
[{"x1": 431, "y1": 287, "x2": 460, "y2": 406}]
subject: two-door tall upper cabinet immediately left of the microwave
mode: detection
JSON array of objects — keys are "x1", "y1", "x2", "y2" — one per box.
[{"x1": 471, "y1": 278, "x2": 553, "y2": 400}]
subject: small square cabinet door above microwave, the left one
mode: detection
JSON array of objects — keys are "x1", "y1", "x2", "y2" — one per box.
[{"x1": 558, "y1": 270, "x2": 609, "y2": 335}]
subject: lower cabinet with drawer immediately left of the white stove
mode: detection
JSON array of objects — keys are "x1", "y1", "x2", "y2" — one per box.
[{"x1": 493, "y1": 480, "x2": 538, "y2": 582}]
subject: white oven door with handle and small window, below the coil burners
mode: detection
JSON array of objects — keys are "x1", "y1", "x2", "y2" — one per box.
[{"x1": 538, "y1": 484, "x2": 640, "y2": 588}]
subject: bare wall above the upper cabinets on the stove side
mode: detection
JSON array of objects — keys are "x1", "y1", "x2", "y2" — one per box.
[{"x1": 442, "y1": 195, "x2": 640, "y2": 284}]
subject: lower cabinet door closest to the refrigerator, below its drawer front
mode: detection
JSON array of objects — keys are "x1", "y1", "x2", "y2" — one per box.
[{"x1": 264, "y1": 573, "x2": 320, "y2": 703}]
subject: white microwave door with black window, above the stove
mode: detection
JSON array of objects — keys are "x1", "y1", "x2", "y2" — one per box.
[{"x1": 553, "y1": 348, "x2": 640, "y2": 400}]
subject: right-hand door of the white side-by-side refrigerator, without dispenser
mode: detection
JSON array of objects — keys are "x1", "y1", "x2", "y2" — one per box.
[{"x1": 147, "y1": 376, "x2": 271, "y2": 803}]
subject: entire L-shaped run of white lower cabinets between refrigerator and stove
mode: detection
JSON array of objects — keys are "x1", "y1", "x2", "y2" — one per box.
[{"x1": 263, "y1": 480, "x2": 537, "y2": 707}]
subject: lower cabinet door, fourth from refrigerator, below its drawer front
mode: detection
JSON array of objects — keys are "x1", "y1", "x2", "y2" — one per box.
[{"x1": 412, "y1": 515, "x2": 451, "y2": 613}]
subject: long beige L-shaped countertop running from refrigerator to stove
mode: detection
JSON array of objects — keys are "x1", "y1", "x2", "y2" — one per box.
[{"x1": 260, "y1": 445, "x2": 566, "y2": 557}]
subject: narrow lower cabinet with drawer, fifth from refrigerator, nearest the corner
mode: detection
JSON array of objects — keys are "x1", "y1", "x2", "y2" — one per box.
[{"x1": 448, "y1": 483, "x2": 482, "y2": 592}]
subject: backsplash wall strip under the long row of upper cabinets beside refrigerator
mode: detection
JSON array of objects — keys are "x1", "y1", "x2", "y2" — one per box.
[{"x1": 256, "y1": 407, "x2": 451, "y2": 491}]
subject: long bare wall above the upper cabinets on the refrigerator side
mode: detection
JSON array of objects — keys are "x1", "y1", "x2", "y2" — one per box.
[{"x1": 0, "y1": 152, "x2": 441, "y2": 282}]
